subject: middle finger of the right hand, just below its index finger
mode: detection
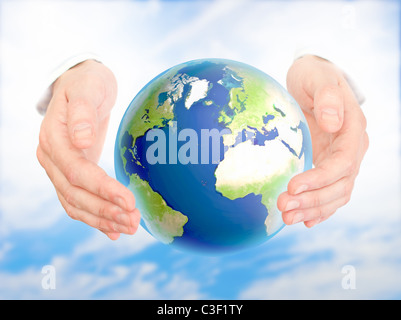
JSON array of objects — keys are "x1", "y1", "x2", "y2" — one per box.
[{"x1": 277, "y1": 176, "x2": 355, "y2": 212}]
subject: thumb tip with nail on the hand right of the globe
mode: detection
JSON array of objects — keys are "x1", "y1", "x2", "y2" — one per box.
[{"x1": 313, "y1": 84, "x2": 344, "y2": 133}]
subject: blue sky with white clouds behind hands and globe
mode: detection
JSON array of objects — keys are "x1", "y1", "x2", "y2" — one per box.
[{"x1": 0, "y1": 0, "x2": 401, "y2": 299}]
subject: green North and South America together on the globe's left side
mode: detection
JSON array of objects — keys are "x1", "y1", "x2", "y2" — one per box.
[{"x1": 120, "y1": 66, "x2": 198, "y2": 243}]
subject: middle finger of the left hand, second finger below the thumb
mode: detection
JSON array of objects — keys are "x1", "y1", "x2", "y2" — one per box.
[{"x1": 37, "y1": 148, "x2": 140, "y2": 234}]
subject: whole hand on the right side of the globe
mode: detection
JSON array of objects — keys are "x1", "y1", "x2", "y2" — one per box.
[{"x1": 277, "y1": 56, "x2": 369, "y2": 228}]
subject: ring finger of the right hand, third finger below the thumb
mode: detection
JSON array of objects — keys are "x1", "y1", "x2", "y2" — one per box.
[{"x1": 282, "y1": 197, "x2": 349, "y2": 225}]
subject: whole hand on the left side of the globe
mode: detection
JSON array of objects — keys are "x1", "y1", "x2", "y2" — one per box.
[{"x1": 37, "y1": 60, "x2": 140, "y2": 240}]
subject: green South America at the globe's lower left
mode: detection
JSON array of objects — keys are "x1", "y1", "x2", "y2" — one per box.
[{"x1": 128, "y1": 174, "x2": 188, "y2": 243}]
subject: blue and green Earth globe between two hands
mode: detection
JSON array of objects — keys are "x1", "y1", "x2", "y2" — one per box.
[{"x1": 115, "y1": 59, "x2": 312, "y2": 254}]
